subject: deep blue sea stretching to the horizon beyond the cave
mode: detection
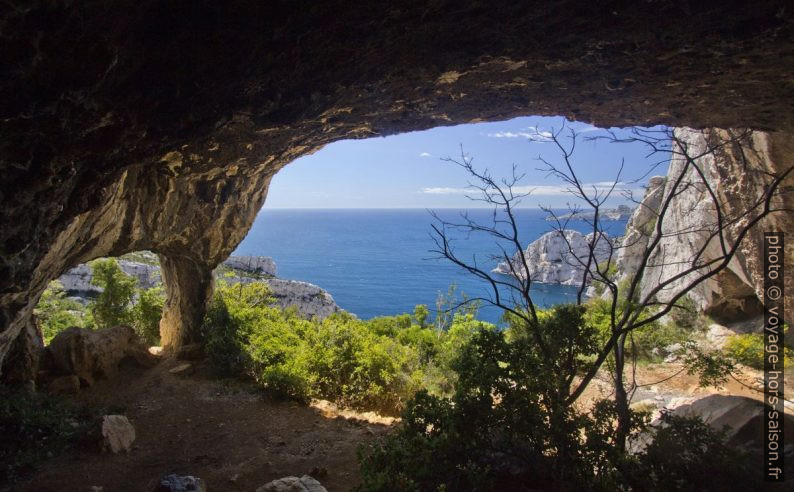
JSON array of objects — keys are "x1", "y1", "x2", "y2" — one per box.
[{"x1": 235, "y1": 209, "x2": 626, "y2": 323}]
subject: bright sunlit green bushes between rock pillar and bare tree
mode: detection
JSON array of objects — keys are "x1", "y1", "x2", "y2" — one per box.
[{"x1": 202, "y1": 282, "x2": 493, "y2": 414}]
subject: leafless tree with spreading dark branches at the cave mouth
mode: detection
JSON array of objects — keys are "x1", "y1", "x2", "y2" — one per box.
[{"x1": 433, "y1": 125, "x2": 794, "y2": 449}]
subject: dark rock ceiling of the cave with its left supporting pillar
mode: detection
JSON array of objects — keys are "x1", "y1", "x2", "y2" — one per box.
[{"x1": 0, "y1": 0, "x2": 794, "y2": 380}]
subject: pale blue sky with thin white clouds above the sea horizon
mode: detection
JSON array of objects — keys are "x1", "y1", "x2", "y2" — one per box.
[{"x1": 265, "y1": 117, "x2": 667, "y2": 209}]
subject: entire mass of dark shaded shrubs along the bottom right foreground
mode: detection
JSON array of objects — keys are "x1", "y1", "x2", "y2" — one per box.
[{"x1": 359, "y1": 320, "x2": 752, "y2": 491}]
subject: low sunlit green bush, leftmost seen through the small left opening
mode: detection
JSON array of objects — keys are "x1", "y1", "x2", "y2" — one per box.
[{"x1": 34, "y1": 280, "x2": 93, "y2": 343}]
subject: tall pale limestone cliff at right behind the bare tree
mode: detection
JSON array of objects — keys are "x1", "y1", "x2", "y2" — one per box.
[{"x1": 618, "y1": 128, "x2": 794, "y2": 320}]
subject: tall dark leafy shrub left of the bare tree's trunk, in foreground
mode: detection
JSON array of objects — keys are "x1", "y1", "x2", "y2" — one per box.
[{"x1": 359, "y1": 320, "x2": 644, "y2": 491}]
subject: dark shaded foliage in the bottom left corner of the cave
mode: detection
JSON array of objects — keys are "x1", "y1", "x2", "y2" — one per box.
[{"x1": 0, "y1": 388, "x2": 96, "y2": 488}]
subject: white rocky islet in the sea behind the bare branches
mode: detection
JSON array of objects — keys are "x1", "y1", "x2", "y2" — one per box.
[{"x1": 493, "y1": 229, "x2": 613, "y2": 285}]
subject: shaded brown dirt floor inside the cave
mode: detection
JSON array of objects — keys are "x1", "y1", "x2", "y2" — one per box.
[{"x1": 19, "y1": 360, "x2": 389, "y2": 492}]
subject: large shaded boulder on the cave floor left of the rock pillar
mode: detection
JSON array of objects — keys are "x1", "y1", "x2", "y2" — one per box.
[{"x1": 48, "y1": 326, "x2": 157, "y2": 385}]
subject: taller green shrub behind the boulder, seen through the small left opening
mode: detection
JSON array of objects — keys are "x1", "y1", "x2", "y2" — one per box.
[{"x1": 90, "y1": 258, "x2": 135, "y2": 328}]
